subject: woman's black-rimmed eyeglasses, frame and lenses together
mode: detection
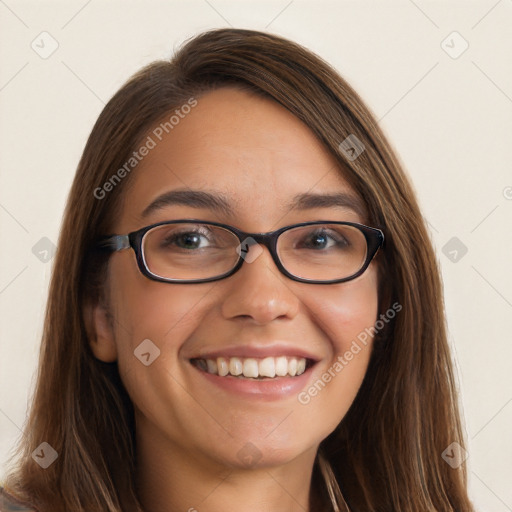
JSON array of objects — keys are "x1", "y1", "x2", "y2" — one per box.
[{"x1": 97, "y1": 219, "x2": 384, "y2": 284}]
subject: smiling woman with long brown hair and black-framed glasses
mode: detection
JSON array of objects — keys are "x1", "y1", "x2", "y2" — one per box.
[{"x1": 4, "y1": 29, "x2": 473, "y2": 512}]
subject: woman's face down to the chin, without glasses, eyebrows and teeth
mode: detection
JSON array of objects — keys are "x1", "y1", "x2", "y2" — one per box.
[{"x1": 92, "y1": 88, "x2": 378, "y2": 467}]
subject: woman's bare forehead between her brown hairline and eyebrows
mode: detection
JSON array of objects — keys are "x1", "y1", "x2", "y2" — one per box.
[{"x1": 123, "y1": 87, "x2": 364, "y2": 227}]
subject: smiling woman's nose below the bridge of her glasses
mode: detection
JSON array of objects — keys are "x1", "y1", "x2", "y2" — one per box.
[{"x1": 222, "y1": 245, "x2": 304, "y2": 324}]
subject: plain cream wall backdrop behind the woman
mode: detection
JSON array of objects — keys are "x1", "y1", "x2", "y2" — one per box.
[{"x1": 0, "y1": 0, "x2": 512, "y2": 512}]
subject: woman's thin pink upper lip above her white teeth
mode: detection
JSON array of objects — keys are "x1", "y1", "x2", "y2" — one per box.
[{"x1": 191, "y1": 343, "x2": 321, "y2": 363}]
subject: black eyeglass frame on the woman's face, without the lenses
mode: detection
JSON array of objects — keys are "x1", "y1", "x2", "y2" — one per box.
[{"x1": 96, "y1": 219, "x2": 384, "y2": 284}]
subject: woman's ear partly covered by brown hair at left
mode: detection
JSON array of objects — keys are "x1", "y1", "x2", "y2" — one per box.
[{"x1": 84, "y1": 302, "x2": 117, "y2": 363}]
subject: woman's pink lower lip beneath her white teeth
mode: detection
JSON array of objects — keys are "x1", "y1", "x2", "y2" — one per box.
[{"x1": 191, "y1": 364, "x2": 312, "y2": 400}]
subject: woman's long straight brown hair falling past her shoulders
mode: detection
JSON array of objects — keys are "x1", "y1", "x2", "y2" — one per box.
[{"x1": 7, "y1": 29, "x2": 473, "y2": 512}]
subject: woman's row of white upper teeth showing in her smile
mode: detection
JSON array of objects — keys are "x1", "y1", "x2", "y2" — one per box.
[{"x1": 197, "y1": 356, "x2": 306, "y2": 378}]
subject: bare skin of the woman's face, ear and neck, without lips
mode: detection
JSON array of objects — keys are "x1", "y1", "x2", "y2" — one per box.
[{"x1": 87, "y1": 88, "x2": 378, "y2": 512}]
